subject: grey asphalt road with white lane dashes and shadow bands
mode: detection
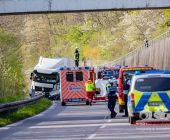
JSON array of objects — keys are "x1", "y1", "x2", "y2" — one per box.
[{"x1": 0, "y1": 101, "x2": 170, "y2": 140}]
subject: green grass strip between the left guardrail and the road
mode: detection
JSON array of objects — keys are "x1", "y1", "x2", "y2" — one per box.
[{"x1": 0, "y1": 98, "x2": 51, "y2": 126}]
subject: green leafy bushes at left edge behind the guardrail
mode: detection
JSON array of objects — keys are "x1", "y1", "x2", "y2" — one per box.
[{"x1": 0, "y1": 29, "x2": 28, "y2": 98}]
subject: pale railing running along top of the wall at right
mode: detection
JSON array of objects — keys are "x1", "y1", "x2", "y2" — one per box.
[{"x1": 93, "y1": 28, "x2": 170, "y2": 69}]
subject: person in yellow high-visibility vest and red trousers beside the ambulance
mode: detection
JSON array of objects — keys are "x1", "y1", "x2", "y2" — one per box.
[{"x1": 85, "y1": 78, "x2": 94, "y2": 105}]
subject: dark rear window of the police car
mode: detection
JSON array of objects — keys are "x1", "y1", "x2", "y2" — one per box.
[{"x1": 134, "y1": 77, "x2": 170, "y2": 92}]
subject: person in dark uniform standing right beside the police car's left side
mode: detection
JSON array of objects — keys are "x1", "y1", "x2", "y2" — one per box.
[{"x1": 122, "y1": 73, "x2": 131, "y2": 117}]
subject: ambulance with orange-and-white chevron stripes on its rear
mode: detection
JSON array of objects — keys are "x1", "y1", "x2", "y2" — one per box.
[{"x1": 60, "y1": 67, "x2": 95, "y2": 106}]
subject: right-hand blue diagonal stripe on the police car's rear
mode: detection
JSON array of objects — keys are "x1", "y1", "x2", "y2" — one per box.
[{"x1": 158, "y1": 92, "x2": 170, "y2": 110}]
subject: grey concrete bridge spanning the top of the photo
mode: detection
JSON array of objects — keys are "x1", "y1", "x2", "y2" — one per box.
[{"x1": 0, "y1": 0, "x2": 170, "y2": 15}]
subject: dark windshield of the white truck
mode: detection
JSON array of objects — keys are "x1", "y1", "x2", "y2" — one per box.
[{"x1": 34, "y1": 73, "x2": 56, "y2": 83}]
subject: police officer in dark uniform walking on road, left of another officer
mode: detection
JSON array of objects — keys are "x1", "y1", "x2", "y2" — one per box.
[{"x1": 106, "y1": 80, "x2": 119, "y2": 118}]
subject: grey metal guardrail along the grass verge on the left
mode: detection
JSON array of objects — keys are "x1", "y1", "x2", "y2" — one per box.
[{"x1": 0, "y1": 94, "x2": 44, "y2": 114}]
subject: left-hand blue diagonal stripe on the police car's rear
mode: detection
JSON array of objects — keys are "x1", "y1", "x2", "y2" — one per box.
[{"x1": 135, "y1": 93, "x2": 152, "y2": 111}]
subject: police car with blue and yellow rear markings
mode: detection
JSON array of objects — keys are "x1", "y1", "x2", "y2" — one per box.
[{"x1": 127, "y1": 70, "x2": 170, "y2": 124}]
